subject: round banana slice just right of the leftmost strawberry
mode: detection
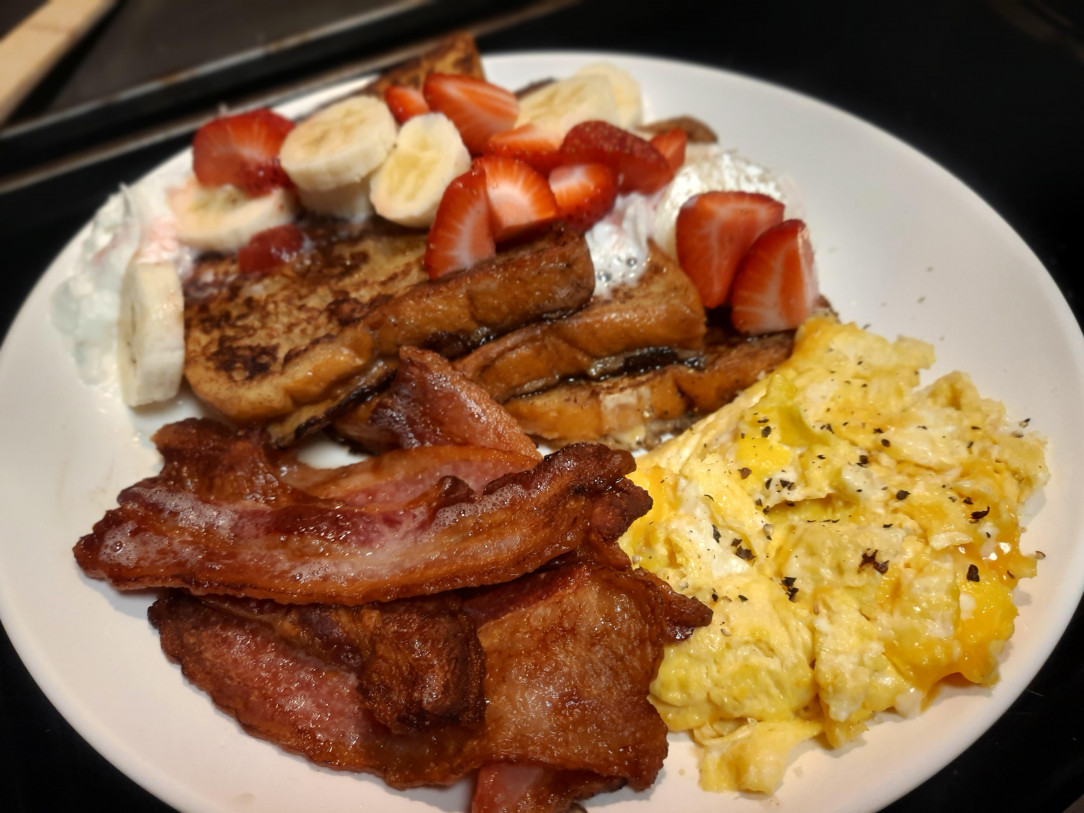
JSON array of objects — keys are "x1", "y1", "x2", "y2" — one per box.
[{"x1": 279, "y1": 96, "x2": 396, "y2": 191}]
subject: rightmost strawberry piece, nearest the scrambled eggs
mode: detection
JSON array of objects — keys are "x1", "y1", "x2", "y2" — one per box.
[{"x1": 731, "y1": 220, "x2": 817, "y2": 334}]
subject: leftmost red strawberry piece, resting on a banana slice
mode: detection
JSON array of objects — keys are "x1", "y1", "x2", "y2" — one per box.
[{"x1": 192, "y1": 107, "x2": 294, "y2": 196}]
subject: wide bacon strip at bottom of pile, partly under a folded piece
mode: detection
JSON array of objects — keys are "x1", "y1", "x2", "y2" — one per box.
[{"x1": 151, "y1": 565, "x2": 711, "y2": 792}]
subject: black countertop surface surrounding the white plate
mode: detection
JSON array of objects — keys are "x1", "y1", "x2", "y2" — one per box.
[{"x1": 0, "y1": 0, "x2": 1084, "y2": 813}]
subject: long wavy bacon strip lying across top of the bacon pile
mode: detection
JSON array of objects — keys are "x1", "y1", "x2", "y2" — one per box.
[{"x1": 75, "y1": 418, "x2": 634, "y2": 605}]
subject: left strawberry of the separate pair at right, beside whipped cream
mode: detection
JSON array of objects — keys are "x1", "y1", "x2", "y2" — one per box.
[{"x1": 674, "y1": 192, "x2": 783, "y2": 308}]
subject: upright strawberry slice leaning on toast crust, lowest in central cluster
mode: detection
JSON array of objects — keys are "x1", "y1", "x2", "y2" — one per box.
[{"x1": 425, "y1": 167, "x2": 496, "y2": 280}]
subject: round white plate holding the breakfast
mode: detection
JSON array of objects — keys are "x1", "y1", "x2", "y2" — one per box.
[{"x1": 0, "y1": 54, "x2": 1084, "y2": 813}]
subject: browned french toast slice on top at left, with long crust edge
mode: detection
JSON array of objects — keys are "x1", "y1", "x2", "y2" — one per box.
[{"x1": 185, "y1": 220, "x2": 594, "y2": 443}]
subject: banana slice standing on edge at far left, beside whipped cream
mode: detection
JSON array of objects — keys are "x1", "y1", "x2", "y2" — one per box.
[{"x1": 117, "y1": 259, "x2": 184, "y2": 407}]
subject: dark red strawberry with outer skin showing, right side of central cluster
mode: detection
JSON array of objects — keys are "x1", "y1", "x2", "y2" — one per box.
[{"x1": 560, "y1": 121, "x2": 674, "y2": 194}]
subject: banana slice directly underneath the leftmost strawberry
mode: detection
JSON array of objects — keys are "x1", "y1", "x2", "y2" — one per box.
[{"x1": 168, "y1": 178, "x2": 296, "y2": 254}]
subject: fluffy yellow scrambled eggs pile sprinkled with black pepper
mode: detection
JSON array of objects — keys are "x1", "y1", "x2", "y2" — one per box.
[{"x1": 621, "y1": 318, "x2": 1047, "y2": 792}]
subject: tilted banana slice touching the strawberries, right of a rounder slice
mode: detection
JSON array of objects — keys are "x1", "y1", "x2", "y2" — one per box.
[{"x1": 370, "y1": 113, "x2": 470, "y2": 227}]
